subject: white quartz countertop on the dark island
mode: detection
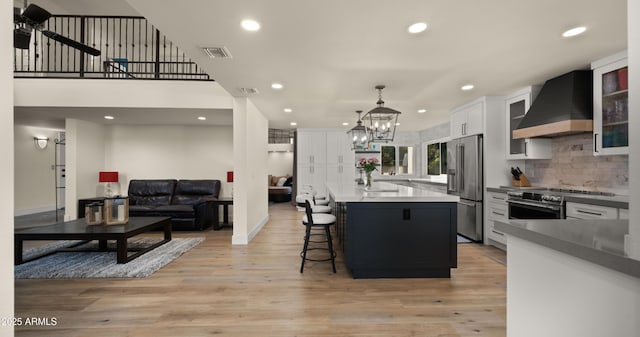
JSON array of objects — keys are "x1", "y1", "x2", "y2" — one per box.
[{"x1": 327, "y1": 181, "x2": 460, "y2": 202}]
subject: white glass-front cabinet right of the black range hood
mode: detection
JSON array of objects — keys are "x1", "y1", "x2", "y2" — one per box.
[{"x1": 591, "y1": 51, "x2": 629, "y2": 155}]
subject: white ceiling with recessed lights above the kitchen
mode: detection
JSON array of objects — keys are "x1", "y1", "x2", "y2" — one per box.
[{"x1": 18, "y1": 0, "x2": 627, "y2": 130}]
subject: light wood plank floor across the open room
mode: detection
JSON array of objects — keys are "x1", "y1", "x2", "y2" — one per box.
[{"x1": 15, "y1": 203, "x2": 506, "y2": 337}]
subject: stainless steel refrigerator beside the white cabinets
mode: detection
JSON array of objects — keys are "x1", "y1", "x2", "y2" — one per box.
[{"x1": 447, "y1": 135, "x2": 484, "y2": 241}]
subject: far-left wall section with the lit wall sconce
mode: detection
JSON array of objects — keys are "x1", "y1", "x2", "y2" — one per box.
[{"x1": 13, "y1": 125, "x2": 60, "y2": 216}]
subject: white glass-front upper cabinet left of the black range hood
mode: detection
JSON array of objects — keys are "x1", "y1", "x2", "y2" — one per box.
[{"x1": 505, "y1": 86, "x2": 551, "y2": 159}]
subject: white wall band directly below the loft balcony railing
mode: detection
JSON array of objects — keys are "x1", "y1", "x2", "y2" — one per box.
[{"x1": 12, "y1": 78, "x2": 232, "y2": 109}]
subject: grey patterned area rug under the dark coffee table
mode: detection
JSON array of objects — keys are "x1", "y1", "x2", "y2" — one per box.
[{"x1": 14, "y1": 237, "x2": 204, "y2": 279}]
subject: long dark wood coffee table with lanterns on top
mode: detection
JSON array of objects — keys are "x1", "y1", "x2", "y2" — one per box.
[{"x1": 14, "y1": 217, "x2": 171, "y2": 265}]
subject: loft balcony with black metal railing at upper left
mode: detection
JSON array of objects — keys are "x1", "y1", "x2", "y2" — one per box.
[{"x1": 13, "y1": 15, "x2": 212, "y2": 81}]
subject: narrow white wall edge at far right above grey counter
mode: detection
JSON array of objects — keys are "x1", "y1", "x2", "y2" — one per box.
[{"x1": 627, "y1": 0, "x2": 640, "y2": 260}]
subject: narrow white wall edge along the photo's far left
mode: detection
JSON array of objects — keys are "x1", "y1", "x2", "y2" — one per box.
[{"x1": 0, "y1": 1, "x2": 15, "y2": 337}]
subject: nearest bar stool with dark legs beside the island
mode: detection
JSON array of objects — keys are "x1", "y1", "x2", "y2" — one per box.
[{"x1": 300, "y1": 200, "x2": 336, "y2": 273}]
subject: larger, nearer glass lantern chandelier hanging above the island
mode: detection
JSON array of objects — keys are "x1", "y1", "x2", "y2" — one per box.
[{"x1": 363, "y1": 85, "x2": 400, "y2": 143}]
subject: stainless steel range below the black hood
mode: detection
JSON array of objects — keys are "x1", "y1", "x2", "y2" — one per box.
[{"x1": 507, "y1": 190, "x2": 565, "y2": 219}]
